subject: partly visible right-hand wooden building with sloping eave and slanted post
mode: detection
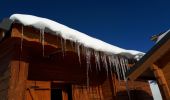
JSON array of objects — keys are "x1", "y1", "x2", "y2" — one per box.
[{"x1": 127, "y1": 31, "x2": 170, "y2": 100}]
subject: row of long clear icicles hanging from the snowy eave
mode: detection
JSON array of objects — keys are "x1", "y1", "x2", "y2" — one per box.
[{"x1": 21, "y1": 26, "x2": 133, "y2": 98}]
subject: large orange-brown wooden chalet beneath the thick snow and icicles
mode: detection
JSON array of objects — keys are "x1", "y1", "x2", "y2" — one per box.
[{"x1": 0, "y1": 14, "x2": 153, "y2": 100}]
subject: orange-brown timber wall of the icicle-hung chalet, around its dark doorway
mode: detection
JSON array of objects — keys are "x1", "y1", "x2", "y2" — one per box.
[{"x1": 0, "y1": 25, "x2": 152, "y2": 100}]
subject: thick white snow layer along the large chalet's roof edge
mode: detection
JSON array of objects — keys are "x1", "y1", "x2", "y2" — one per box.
[{"x1": 10, "y1": 14, "x2": 143, "y2": 55}]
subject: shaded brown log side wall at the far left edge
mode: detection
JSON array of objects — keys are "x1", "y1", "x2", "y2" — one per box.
[{"x1": 0, "y1": 35, "x2": 14, "y2": 100}]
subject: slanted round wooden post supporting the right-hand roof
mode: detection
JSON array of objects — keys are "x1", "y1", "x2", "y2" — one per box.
[{"x1": 151, "y1": 64, "x2": 170, "y2": 100}]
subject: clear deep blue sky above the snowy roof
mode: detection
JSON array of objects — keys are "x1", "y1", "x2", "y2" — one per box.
[{"x1": 0, "y1": 0, "x2": 170, "y2": 52}]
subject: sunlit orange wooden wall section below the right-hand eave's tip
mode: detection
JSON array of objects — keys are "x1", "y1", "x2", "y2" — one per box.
[{"x1": 116, "y1": 80, "x2": 153, "y2": 100}]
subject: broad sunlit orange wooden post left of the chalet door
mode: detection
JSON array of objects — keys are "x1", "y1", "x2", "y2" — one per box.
[{"x1": 8, "y1": 61, "x2": 28, "y2": 100}]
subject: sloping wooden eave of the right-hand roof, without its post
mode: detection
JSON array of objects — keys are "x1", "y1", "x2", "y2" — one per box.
[{"x1": 126, "y1": 32, "x2": 170, "y2": 80}]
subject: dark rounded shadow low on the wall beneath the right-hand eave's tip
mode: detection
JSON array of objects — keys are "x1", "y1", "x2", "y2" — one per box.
[{"x1": 116, "y1": 90, "x2": 154, "y2": 100}]
